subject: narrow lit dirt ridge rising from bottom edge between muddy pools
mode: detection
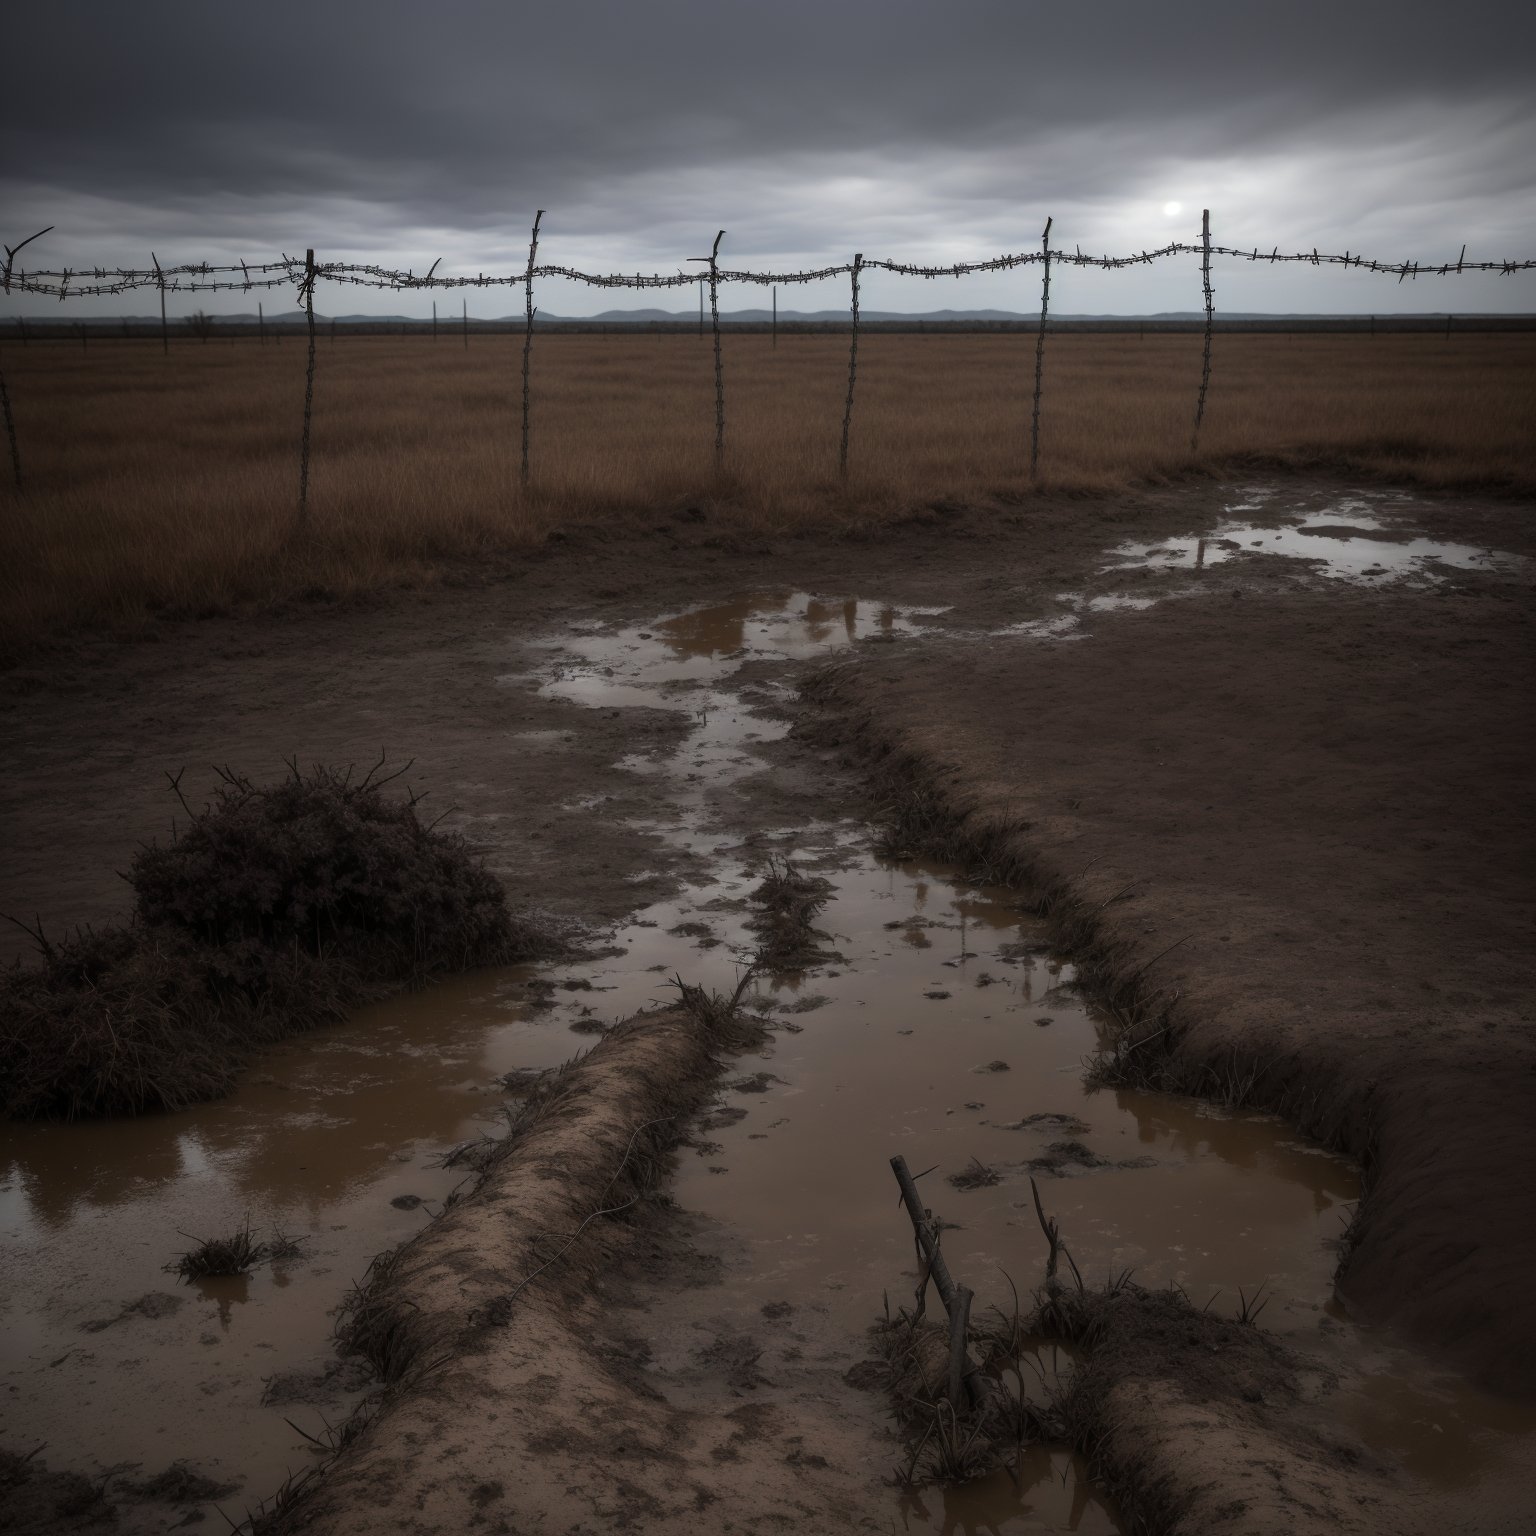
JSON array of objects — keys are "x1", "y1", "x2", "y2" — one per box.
[{"x1": 261, "y1": 989, "x2": 878, "y2": 1533}]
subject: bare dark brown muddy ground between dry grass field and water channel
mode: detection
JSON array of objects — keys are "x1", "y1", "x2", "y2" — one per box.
[{"x1": 0, "y1": 481, "x2": 1536, "y2": 1530}]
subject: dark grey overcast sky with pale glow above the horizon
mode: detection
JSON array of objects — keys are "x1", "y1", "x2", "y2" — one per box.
[{"x1": 0, "y1": 0, "x2": 1536, "y2": 318}]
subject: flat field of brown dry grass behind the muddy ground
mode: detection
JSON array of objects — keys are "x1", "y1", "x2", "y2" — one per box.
[{"x1": 0, "y1": 333, "x2": 1536, "y2": 651}]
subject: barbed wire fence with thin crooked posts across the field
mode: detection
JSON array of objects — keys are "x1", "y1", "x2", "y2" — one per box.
[{"x1": 0, "y1": 209, "x2": 1536, "y2": 503}]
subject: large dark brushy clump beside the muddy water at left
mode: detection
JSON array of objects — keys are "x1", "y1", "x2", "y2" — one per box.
[{"x1": 0, "y1": 766, "x2": 553, "y2": 1118}]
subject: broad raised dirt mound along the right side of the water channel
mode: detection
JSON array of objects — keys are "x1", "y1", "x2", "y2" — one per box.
[{"x1": 811, "y1": 579, "x2": 1536, "y2": 1396}]
